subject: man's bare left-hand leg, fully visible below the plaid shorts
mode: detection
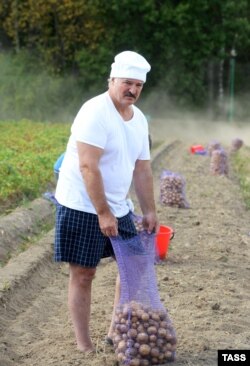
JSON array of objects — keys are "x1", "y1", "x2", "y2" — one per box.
[{"x1": 68, "y1": 264, "x2": 96, "y2": 352}]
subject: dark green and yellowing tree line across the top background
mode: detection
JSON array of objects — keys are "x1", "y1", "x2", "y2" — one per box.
[{"x1": 0, "y1": 0, "x2": 250, "y2": 114}]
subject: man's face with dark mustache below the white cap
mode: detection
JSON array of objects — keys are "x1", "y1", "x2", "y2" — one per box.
[{"x1": 109, "y1": 78, "x2": 143, "y2": 106}]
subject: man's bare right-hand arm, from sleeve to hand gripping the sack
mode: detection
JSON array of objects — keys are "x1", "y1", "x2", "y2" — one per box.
[{"x1": 133, "y1": 160, "x2": 159, "y2": 232}]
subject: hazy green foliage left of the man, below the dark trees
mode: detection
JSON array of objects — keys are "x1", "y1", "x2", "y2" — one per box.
[{"x1": 0, "y1": 51, "x2": 83, "y2": 122}]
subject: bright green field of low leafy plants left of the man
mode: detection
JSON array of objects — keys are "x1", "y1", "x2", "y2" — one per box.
[{"x1": 0, "y1": 120, "x2": 70, "y2": 212}]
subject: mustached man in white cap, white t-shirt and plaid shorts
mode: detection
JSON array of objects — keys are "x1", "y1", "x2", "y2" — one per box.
[{"x1": 55, "y1": 51, "x2": 158, "y2": 352}]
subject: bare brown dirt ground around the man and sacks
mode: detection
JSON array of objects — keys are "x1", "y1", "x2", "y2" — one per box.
[{"x1": 0, "y1": 118, "x2": 250, "y2": 366}]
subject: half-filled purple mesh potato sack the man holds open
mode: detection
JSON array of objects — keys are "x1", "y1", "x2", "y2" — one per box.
[{"x1": 111, "y1": 230, "x2": 177, "y2": 366}]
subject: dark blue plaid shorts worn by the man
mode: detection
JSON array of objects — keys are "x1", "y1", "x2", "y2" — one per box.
[{"x1": 54, "y1": 204, "x2": 137, "y2": 267}]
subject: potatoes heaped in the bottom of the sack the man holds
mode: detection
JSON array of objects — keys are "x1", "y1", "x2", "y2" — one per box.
[{"x1": 113, "y1": 301, "x2": 177, "y2": 366}]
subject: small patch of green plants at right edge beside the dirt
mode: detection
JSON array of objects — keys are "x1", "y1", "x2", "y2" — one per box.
[{"x1": 232, "y1": 146, "x2": 250, "y2": 209}]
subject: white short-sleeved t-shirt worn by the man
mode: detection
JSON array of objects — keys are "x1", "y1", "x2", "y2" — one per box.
[{"x1": 56, "y1": 92, "x2": 150, "y2": 217}]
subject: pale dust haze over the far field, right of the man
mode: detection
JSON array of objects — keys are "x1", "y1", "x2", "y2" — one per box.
[{"x1": 140, "y1": 91, "x2": 250, "y2": 146}]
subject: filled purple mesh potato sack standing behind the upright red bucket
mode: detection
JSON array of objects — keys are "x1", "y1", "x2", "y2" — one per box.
[{"x1": 160, "y1": 170, "x2": 190, "y2": 208}]
